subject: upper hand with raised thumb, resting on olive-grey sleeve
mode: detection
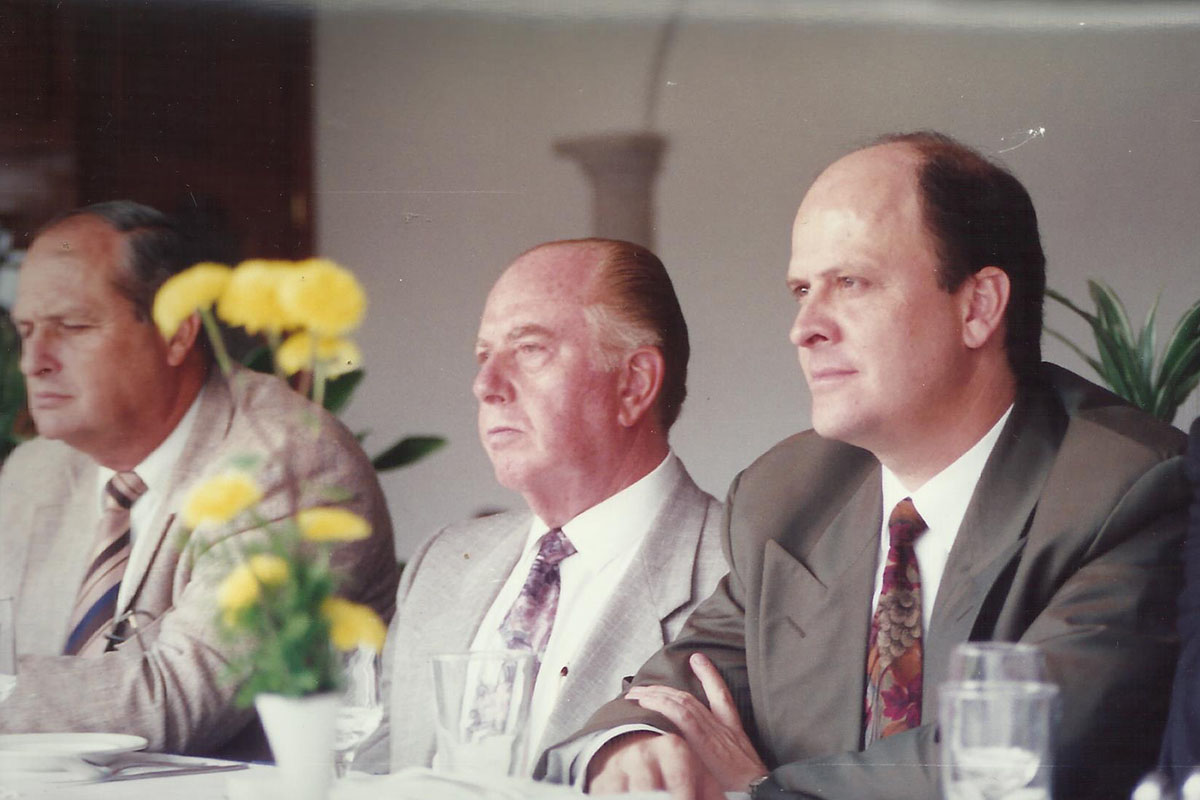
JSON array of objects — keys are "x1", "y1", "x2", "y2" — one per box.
[{"x1": 619, "y1": 652, "x2": 768, "y2": 792}]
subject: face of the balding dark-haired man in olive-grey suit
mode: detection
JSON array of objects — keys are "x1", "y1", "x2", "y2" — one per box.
[{"x1": 787, "y1": 144, "x2": 970, "y2": 453}]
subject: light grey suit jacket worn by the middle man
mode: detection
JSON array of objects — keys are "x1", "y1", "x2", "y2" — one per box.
[{"x1": 389, "y1": 460, "x2": 726, "y2": 771}]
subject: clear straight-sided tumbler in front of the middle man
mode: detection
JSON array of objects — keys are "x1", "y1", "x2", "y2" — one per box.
[{"x1": 433, "y1": 650, "x2": 534, "y2": 776}]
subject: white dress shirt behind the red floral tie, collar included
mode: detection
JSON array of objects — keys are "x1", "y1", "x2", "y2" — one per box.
[{"x1": 870, "y1": 405, "x2": 1013, "y2": 634}]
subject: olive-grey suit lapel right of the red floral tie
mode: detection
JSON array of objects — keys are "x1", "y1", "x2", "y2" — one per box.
[{"x1": 922, "y1": 388, "x2": 1061, "y2": 720}]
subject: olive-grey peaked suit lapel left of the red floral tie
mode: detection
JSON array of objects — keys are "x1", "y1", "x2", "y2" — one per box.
[{"x1": 755, "y1": 467, "x2": 883, "y2": 752}]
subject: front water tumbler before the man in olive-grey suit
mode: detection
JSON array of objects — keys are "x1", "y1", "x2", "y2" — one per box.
[{"x1": 938, "y1": 681, "x2": 1058, "y2": 800}]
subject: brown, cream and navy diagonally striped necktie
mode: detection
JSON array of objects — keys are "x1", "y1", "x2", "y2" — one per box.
[{"x1": 62, "y1": 473, "x2": 146, "y2": 656}]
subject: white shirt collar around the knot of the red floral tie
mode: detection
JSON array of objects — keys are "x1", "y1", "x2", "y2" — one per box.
[{"x1": 882, "y1": 405, "x2": 1013, "y2": 530}]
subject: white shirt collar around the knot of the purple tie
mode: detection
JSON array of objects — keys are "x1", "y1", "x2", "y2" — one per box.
[{"x1": 527, "y1": 451, "x2": 683, "y2": 564}]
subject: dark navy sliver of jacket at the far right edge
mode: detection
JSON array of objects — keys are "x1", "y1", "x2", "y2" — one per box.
[{"x1": 1162, "y1": 417, "x2": 1200, "y2": 782}]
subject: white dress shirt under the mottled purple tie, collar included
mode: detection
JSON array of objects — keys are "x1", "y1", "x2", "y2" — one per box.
[{"x1": 470, "y1": 453, "x2": 683, "y2": 759}]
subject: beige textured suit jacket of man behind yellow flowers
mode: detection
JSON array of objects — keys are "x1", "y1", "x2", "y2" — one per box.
[{"x1": 0, "y1": 369, "x2": 398, "y2": 752}]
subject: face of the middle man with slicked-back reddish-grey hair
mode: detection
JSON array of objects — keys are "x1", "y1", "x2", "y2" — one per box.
[{"x1": 474, "y1": 246, "x2": 618, "y2": 506}]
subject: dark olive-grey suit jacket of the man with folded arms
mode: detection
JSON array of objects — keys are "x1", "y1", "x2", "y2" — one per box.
[{"x1": 547, "y1": 367, "x2": 1187, "y2": 799}]
